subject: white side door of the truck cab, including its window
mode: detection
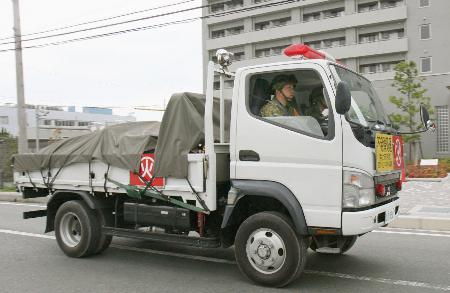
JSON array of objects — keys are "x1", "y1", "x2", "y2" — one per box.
[{"x1": 231, "y1": 63, "x2": 342, "y2": 228}]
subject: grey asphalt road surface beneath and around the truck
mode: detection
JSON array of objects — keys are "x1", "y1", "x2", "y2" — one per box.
[{"x1": 0, "y1": 202, "x2": 450, "y2": 293}]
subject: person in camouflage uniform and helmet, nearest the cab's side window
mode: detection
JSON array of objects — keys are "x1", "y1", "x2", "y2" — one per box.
[{"x1": 260, "y1": 74, "x2": 300, "y2": 117}]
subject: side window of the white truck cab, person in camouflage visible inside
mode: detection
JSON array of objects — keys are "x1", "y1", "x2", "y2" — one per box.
[{"x1": 248, "y1": 70, "x2": 330, "y2": 138}]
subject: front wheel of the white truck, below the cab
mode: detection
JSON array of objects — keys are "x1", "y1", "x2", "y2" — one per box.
[{"x1": 235, "y1": 212, "x2": 307, "y2": 287}]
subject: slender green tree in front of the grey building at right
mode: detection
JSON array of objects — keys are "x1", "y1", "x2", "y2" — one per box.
[{"x1": 389, "y1": 61, "x2": 433, "y2": 162}]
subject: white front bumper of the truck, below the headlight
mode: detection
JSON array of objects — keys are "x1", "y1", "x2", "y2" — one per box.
[{"x1": 342, "y1": 198, "x2": 400, "y2": 235}]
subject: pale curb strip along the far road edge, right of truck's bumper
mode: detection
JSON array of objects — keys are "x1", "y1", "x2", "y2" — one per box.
[{"x1": 388, "y1": 216, "x2": 450, "y2": 231}]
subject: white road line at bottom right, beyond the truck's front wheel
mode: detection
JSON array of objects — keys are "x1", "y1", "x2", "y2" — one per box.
[{"x1": 304, "y1": 270, "x2": 450, "y2": 291}]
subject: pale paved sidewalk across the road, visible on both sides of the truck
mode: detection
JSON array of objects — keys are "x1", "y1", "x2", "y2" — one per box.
[{"x1": 0, "y1": 174, "x2": 450, "y2": 231}]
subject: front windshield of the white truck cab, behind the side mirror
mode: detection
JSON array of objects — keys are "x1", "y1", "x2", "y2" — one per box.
[{"x1": 332, "y1": 65, "x2": 390, "y2": 126}]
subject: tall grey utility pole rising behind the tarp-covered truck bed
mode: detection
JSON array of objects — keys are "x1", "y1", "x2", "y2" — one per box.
[{"x1": 12, "y1": 0, "x2": 28, "y2": 154}]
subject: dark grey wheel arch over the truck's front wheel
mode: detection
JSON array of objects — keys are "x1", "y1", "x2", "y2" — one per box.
[{"x1": 221, "y1": 180, "x2": 308, "y2": 235}]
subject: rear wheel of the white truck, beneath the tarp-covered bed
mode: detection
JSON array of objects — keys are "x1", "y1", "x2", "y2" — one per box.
[{"x1": 55, "y1": 200, "x2": 101, "y2": 258}]
